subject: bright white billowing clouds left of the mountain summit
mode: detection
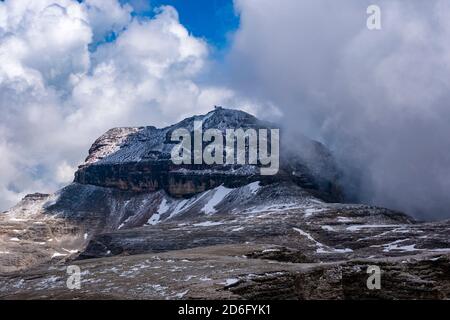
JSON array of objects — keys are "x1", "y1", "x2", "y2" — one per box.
[{"x1": 0, "y1": 0, "x2": 243, "y2": 209}]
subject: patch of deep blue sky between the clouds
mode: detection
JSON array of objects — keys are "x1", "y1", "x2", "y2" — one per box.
[{"x1": 122, "y1": 0, "x2": 239, "y2": 49}]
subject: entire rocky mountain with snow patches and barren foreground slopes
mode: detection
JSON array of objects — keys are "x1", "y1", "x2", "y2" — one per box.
[{"x1": 0, "y1": 107, "x2": 450, "y2": 299}]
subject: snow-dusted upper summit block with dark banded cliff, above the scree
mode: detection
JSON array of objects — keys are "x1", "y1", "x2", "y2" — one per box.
[{"x1": 74, "y1": 108, "x2": 341, "y2": 201}]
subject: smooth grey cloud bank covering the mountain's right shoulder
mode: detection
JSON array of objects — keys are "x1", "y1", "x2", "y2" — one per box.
[{"x1": 228, "y1": 0, "x2": 450, "y2": 219}]
